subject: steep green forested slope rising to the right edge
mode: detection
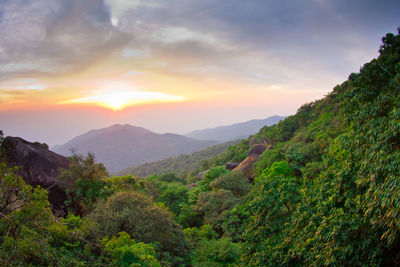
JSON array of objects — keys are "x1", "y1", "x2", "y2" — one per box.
[{"x1": 189, "y1": 29, "x2": 400, "y2": 266}]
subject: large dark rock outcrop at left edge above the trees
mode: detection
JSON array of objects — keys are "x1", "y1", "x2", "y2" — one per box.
[{"x1": 2, "y1": 136, "x2": 71, "y2": 213}]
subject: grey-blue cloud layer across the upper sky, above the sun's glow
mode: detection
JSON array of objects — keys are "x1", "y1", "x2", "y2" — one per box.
[{"x1": 0, "y1": 0, "x2": 400, "y2": 105}]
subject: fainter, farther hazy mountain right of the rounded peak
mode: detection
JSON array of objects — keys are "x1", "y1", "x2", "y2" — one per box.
[{"x1": 185, "y1": 116, "x2": 285, "y2": 142}]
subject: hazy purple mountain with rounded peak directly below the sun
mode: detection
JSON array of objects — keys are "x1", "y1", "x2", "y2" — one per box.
[{"x1": 53, "y1": 124, "x2": 216, "y2": 173}]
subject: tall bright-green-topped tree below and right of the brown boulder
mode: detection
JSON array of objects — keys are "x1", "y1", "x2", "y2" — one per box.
[{"x1": 244, "y1": 161, "x2": 301, "y2": 266}]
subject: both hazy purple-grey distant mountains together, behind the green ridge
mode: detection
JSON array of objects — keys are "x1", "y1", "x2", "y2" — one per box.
[{"x1": 52, "y1": 116, "x2": 284, "y2": 174}]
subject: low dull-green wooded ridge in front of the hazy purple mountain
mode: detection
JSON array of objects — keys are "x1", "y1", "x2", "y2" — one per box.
[{"x1": 116, "y1": 141, "x2": 239, "y2": 178}]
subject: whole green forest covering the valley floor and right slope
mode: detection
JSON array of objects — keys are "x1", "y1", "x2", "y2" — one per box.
[{"x1": 0, "y1": 28, "x2": 400, "y2": 266}]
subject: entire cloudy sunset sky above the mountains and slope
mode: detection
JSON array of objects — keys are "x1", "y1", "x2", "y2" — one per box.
[{"x1": 0, "y1": 0, "x2": 400, "y2": 146}]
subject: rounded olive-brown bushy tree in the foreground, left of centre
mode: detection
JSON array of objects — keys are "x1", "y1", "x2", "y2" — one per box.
[{"x1": 90, "y1": 192, "x2": 187, "y2": 264}]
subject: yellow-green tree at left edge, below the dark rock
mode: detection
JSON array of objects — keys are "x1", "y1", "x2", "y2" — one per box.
[{"x1": 0, "y1": 163, "x2": 56, "y2": 266}]
